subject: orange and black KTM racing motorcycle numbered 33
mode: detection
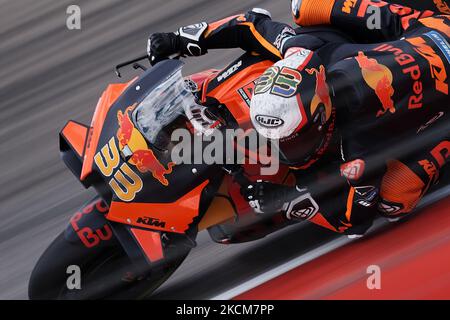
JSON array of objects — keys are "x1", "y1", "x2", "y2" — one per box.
[{"x1": 29, "y1": 54, "x2": 302, "y2": 299}]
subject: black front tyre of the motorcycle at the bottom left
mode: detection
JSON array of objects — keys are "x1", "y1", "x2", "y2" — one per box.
[{"x1": 28, "y1": 232, "x2": 189, "y2": 300}]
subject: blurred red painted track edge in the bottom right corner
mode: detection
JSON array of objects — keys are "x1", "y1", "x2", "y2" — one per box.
[{"x1": 236, "y1": 198, "x2": 450, "y2": 299}]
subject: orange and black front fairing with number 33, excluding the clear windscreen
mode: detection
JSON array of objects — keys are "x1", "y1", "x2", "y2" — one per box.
[{"x1": 69, "y1": 60, "x2": 222, "y2": 233}]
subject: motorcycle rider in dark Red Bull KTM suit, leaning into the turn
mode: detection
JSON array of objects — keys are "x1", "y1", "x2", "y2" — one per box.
[{"x1": 148, "y1": 0, "x2": 450, "y2": 234}]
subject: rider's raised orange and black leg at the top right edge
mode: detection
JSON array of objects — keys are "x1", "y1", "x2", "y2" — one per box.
[{"x1": 292, "y1": 0, "x2": 435, "y2": 42}]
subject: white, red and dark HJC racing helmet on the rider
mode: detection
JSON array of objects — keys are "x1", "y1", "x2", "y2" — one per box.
[{"x1": 250, "y1": 48, "x2": 335, "y2": 169}]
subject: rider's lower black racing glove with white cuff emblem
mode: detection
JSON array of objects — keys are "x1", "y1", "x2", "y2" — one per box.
[{"x1": 241, "y1": 180, "x2": 319, "y2": 220}]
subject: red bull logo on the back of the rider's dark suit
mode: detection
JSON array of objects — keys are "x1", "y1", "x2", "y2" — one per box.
[{"x1": 355, "y1": 51, "x2": 396, "y2": 117}]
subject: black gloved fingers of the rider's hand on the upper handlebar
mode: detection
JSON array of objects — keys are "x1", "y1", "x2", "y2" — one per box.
[{"x1": 147, "y1": 33, "x2": 180, "y2": 65}]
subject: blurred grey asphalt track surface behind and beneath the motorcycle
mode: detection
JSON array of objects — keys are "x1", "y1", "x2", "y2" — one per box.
[{"x1": 0, "y1": 0, "x2": 448, "y2": 299}]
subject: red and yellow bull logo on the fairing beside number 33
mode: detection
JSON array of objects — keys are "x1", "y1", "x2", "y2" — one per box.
[{"x1": 117, "y1": 104, "x2": 175, "y2": 186}]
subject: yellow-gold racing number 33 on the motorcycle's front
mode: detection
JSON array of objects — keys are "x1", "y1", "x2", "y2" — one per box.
[{"x1": 94, "y1": 137, "x2": 143, "y2": 202}]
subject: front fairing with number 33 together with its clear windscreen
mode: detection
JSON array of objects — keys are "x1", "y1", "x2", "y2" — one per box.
[{"x1": 70, "y1": 60, "x2": 223, "y2": 233}]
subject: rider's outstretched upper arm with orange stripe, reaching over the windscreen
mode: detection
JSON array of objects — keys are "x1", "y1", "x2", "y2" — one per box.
[{"x1": 148, "y1": 8, "x2": 330, "y2": 63}]
